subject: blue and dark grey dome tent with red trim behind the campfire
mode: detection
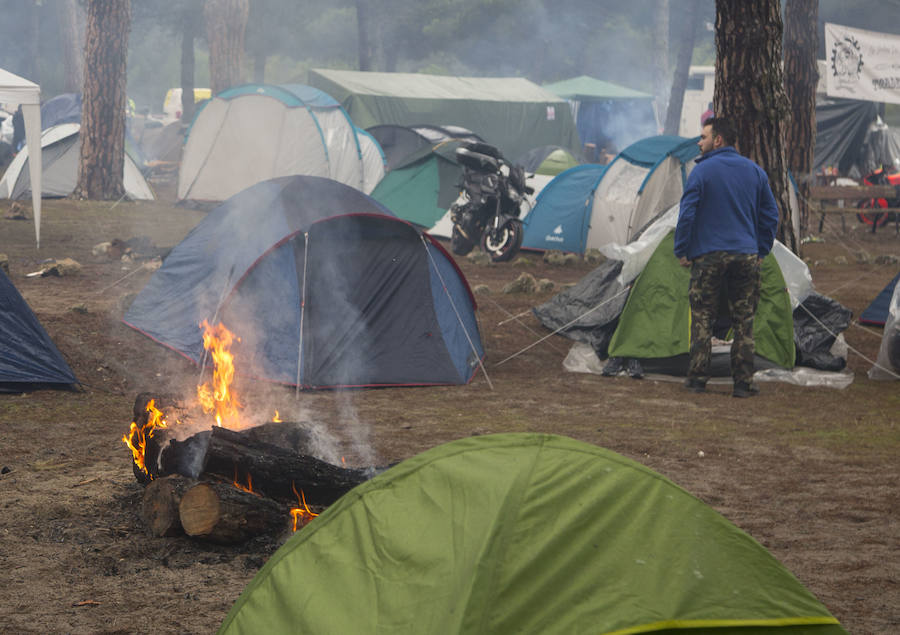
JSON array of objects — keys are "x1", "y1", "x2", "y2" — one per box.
[{"x1": 123, "y1": 176, "x2": 484, "y2": 389}]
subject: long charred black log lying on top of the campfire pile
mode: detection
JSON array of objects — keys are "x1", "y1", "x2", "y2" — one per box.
[{"x1": 202, "y1": 428, "x2": 373, "y2": 506}]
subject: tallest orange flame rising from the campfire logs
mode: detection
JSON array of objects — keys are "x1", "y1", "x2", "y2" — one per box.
[{"x1": 197, "y1": 320, "x2": 243, "y2": 428}]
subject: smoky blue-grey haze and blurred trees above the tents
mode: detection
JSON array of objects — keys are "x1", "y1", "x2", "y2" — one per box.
[{"x1": 0, "y1": 0, "x2": 900, "y2": 129}]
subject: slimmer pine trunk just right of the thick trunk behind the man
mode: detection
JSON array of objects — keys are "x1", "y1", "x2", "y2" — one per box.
[{"x1": 784, "y1": 0, "x2": 819, "y2": 240}]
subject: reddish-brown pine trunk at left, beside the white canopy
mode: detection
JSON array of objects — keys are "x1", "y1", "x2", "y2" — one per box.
[{"x1": 73, "y1": 0, "x2": 131, "y2": 200}]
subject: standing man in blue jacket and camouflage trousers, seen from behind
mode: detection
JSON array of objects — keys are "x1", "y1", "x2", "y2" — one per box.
[{"x1": 675, "y1": 117, "x2": 778, "y2": 397}]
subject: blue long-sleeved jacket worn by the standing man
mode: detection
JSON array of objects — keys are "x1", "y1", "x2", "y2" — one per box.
[{"x1": 675, "y1": 146, "x2": 778, "y2": 260}]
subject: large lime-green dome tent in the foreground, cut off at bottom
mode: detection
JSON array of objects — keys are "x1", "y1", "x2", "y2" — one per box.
[{"x1": 219, "y1": 433, "x2": 845, "y2": 635}]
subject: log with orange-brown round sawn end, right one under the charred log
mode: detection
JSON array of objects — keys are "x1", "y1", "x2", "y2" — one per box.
[{"x1": 178, "y1": 482, "x2": 290, "y2": 544}]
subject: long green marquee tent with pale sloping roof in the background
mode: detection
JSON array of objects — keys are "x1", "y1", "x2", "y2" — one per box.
[{"x1": 307, "y1": 68, "x2": 581, "y2": 159}]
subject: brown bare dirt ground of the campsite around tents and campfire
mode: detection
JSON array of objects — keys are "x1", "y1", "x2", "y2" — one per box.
[{"x1": 0, "y1": 196, "x2": 900, "y2": 634}]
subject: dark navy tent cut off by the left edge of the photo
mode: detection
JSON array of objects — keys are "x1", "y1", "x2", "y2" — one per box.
[{"x1": 0, "y1": 269, "x2": 78, "y2": 392}]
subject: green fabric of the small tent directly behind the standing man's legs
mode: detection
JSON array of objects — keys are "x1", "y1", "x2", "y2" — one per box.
[{"x1": 609, "y1": 232, "x2": 795, "y2": 368}]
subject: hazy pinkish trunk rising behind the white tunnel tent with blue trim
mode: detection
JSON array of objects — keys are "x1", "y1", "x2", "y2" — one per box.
[{"x1": 203, "y1": 0, "x2": 250, "y2": 95}]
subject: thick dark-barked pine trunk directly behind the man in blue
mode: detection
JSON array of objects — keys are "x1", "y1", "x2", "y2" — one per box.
[{"x1": 715, "y1": 0, "x2": 798, "y2": 253}]
